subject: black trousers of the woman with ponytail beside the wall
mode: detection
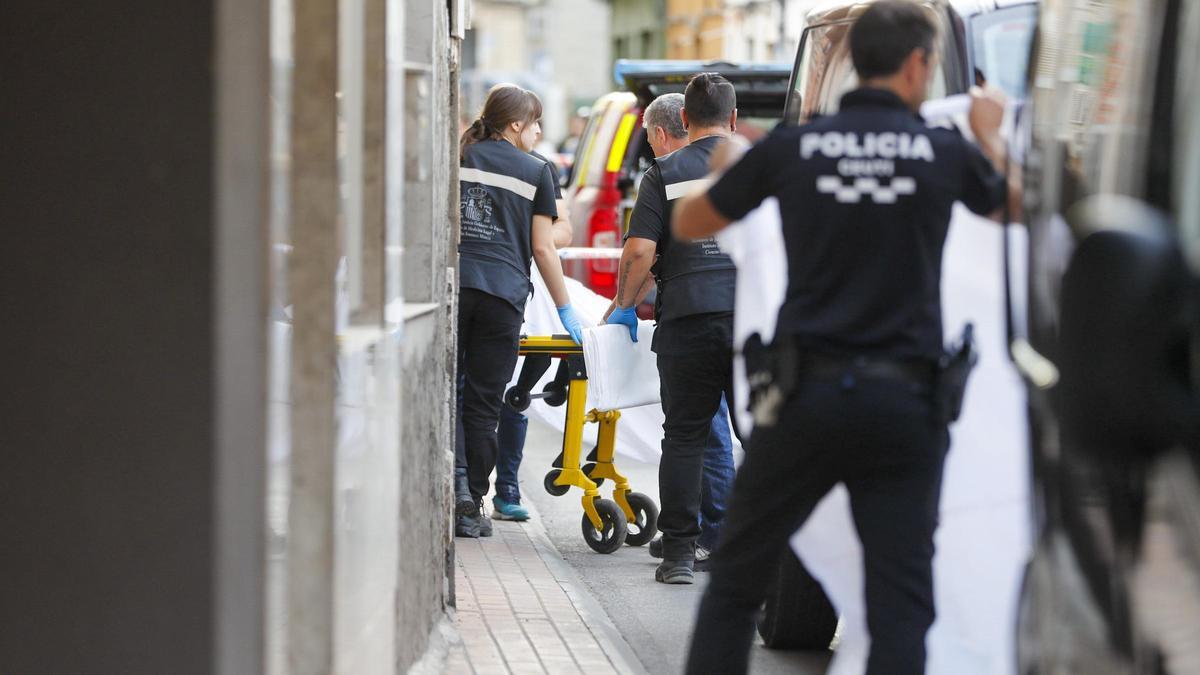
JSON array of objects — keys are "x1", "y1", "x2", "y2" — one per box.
[{"x1": 455, "y1": 288, "x2": 523, "y2": 501}]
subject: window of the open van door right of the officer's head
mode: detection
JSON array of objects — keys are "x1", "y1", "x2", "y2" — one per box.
[{"x1": 971, "y1": 5, "x2": 1038, "y2": 98}]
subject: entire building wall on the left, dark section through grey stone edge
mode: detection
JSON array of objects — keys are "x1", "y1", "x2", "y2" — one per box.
[{"x1": 0, "y1": 0, "x2": 462, "y2": 675}]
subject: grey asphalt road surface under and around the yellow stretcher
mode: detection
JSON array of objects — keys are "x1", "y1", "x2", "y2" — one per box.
[{"x1": 521, "y1": 419, "x2": 829, "y2": 675}]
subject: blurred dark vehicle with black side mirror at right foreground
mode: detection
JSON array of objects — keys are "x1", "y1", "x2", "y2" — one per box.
[{"x1": 1019, "y1": 0, "x2": 1200, "y2": 675}]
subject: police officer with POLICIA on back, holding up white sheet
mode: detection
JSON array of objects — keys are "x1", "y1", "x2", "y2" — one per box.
[{"x1": 674, "y1": 0, "x2": 1004, "y2": 675}]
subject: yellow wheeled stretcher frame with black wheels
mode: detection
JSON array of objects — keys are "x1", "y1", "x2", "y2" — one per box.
[{"x1": 504, "y1": 335, "x2": 659, "y2": 554}]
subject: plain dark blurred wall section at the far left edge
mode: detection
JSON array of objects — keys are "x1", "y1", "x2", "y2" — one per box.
[{"x1": 0, "y1": 0, "x2": 226, "y2": 675}]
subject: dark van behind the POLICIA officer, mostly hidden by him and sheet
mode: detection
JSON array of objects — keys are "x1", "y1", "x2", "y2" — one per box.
[{"x1": 758, "y1": 0, "x2": 1037, "y2": 649}]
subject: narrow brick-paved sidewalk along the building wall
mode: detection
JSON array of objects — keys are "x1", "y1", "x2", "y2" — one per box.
[{"x1": 443, "y1": 504, "x2": 646, "y2": 675}]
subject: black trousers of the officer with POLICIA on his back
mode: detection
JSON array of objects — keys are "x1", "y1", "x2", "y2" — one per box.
[{"x1": 688, "y1": 375, "x2": 949, "y2": 675}]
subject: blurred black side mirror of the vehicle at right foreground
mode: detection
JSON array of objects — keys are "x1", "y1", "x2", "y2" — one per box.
[{"x1": 1052, "y1": 196, "x2": 1196, "y2": 453}]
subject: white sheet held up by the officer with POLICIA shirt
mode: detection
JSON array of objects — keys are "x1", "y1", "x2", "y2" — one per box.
[{"x1": 718, "y1": 98, "x2": 1031, "y2": 675}]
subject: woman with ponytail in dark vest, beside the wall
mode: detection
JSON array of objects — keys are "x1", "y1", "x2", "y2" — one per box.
[{"x1": 455, "y1": 84, "x2": 582, "y2": 537}]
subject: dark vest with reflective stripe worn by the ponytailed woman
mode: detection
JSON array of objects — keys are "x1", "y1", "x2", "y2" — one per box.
[{"x1": 458, "y1": 141, "x2": 553, "y2": 311}]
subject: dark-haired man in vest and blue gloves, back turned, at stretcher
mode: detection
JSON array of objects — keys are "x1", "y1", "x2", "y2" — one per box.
[{"x1": 607, "y1": 73, "x2": 737, "y2": 584}]
